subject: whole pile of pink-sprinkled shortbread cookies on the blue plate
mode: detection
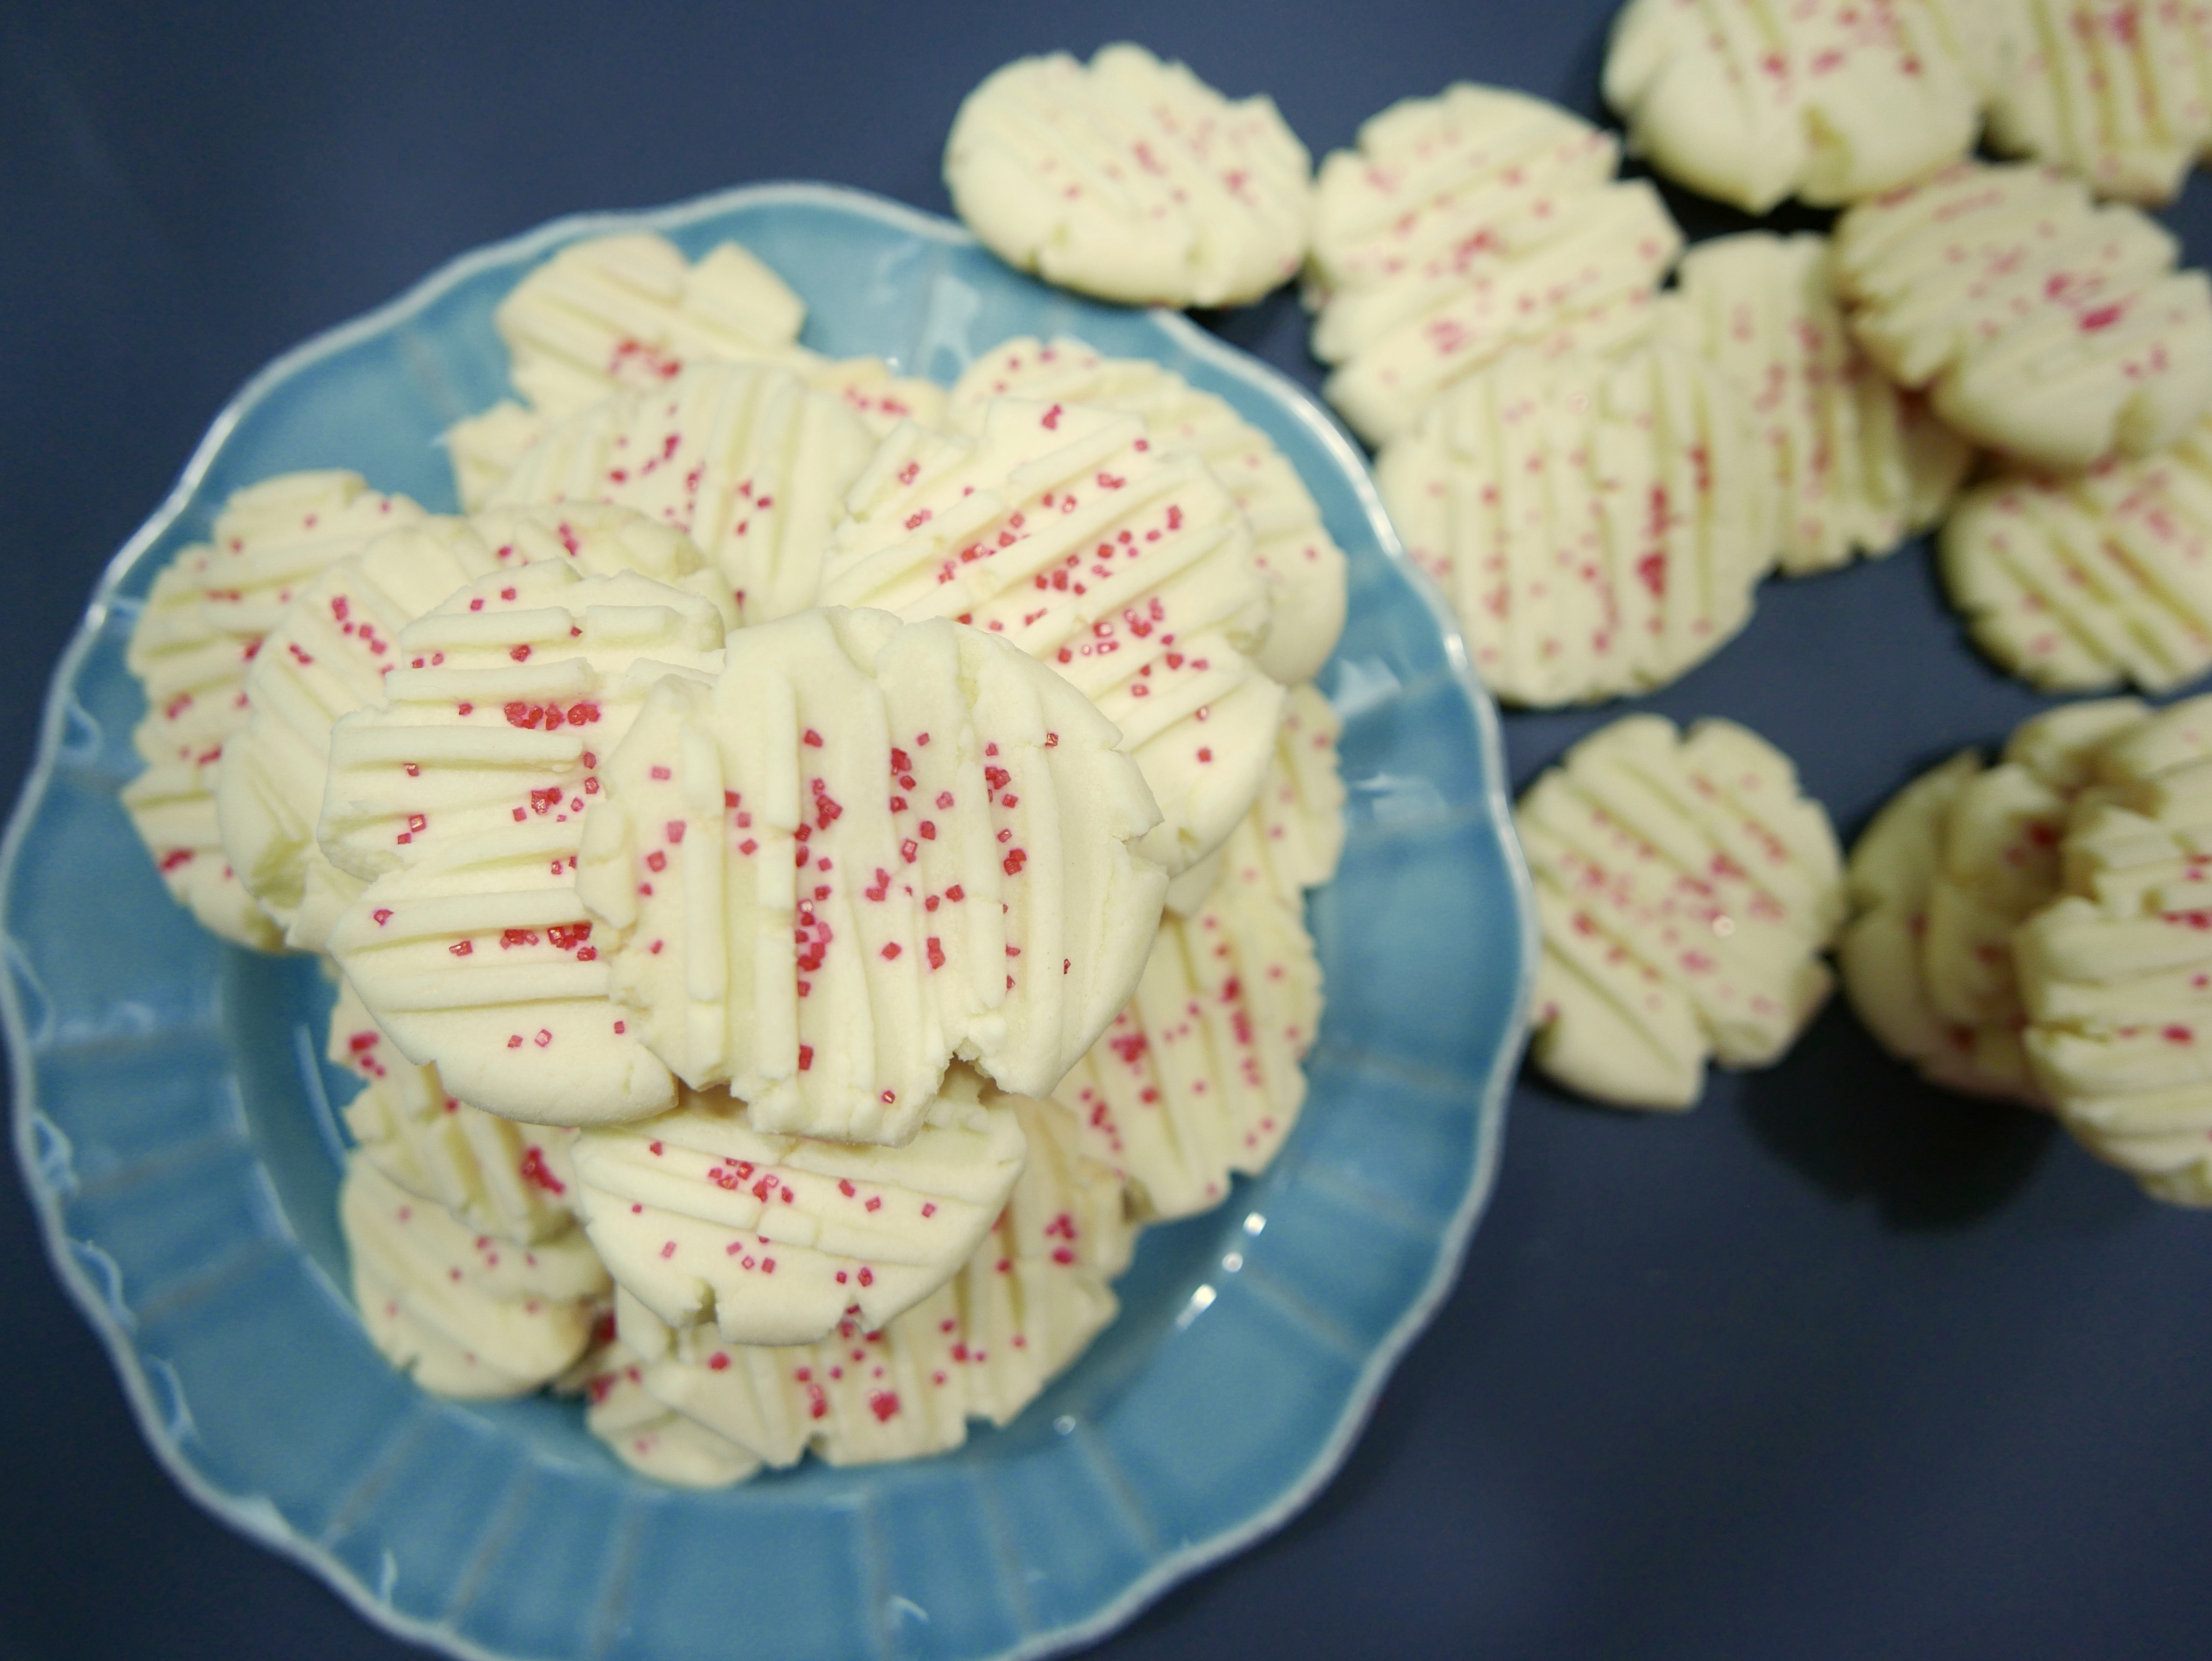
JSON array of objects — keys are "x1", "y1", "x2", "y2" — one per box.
[{"x1": 126, "y1": 175, "x2": 1345, "y2": 1484}]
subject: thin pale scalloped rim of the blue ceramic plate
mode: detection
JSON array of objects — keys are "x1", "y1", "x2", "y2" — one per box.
[{"x1": 0, "y1": 181, "x2": 1540, "y2": 1661}]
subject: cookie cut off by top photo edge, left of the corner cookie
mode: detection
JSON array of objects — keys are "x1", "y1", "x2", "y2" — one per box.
[{"x1": 1606, "y1": 0, "x2": 1982, "y2": 215}]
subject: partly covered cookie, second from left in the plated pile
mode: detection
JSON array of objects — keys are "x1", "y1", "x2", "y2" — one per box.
[{"x1": 215, "y1": 505, "x2": 717, "y2": 951}]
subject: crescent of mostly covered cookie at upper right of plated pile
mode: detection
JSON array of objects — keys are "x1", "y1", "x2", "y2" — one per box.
[{"x1": 949, "y1": 336, "x2": 1345, "y2": 686}]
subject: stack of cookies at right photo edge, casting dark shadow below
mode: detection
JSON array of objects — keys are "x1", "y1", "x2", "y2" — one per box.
[{"x1": 1838, "y1": 697, "x2": 2212, "y2": 1205}]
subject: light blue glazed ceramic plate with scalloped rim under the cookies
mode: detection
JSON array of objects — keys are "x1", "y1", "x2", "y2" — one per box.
[{"x1": 0, "y1": 186, "x2": 1533, "y2": 1661}]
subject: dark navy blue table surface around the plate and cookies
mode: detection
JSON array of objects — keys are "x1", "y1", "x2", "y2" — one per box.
[{"x1": 0, "y1": 0, "x2": 2212, "y2": 1661}]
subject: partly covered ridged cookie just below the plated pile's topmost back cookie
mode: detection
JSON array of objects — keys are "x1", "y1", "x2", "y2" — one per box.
[{"x1": 493, "y1": 363, "x2": 876, "y2": 624}]
